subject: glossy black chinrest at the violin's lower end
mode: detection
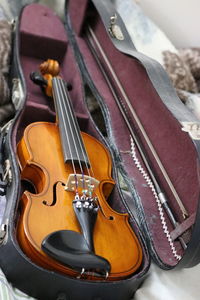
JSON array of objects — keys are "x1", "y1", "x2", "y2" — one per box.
[{"x1": 42, "y1": 230, "x2": 110, "y2": 274}]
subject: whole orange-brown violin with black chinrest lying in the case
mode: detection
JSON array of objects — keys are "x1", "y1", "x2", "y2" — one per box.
[{"x1": 17, "y1": 60, "x2": 142, "y2": 281}]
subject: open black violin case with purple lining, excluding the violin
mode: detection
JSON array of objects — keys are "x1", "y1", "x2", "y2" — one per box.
[{"x1": 0, "y1": 0, "x2": 200, "y2": 300}]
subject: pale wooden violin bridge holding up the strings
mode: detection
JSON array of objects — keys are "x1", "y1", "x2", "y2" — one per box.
[{"x1": 65, "y1": 174, "x2": 99, "y2": 196}]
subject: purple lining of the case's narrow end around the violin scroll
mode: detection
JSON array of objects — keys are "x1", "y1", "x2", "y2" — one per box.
[{"x1": 17, "y1": 4, "x2": 88, "y2": 141}]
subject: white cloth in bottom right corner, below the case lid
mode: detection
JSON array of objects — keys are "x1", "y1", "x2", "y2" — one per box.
[{"x1": 134, "y1": 264, "x2": 200, "y2": 300}]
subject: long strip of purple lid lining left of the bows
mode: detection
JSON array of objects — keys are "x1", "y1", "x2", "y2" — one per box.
[{"x1": 74, "y1": 38, "x2": 182, "y2": 265}]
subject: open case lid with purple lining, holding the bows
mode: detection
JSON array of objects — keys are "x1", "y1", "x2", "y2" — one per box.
[{"x1": 66, "y1": 0, "x2": 200, "y2": 269}]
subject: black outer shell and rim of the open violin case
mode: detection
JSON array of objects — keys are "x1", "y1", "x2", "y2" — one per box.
[{"x1": 0, "y1": 1, "x2": 200, "y2": 300}]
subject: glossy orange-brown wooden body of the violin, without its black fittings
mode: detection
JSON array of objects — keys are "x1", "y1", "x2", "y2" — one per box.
[{"x1": 17, "y1": 122, "x2": 142, "y2": 280}]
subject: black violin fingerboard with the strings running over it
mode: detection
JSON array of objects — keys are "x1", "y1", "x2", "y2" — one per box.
[{"x1": 52, "y1": 77, "x2": 89, "y2": 166}]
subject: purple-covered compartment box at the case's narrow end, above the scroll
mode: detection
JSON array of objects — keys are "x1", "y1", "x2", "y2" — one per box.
[{"x1": 20, "y1": 4, "x2": 67, "y2": 60}]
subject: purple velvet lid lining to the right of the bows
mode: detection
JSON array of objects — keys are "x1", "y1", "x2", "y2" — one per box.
[{"x1": 94, "y1": 18, "x2": 199, "y2": 221}]
